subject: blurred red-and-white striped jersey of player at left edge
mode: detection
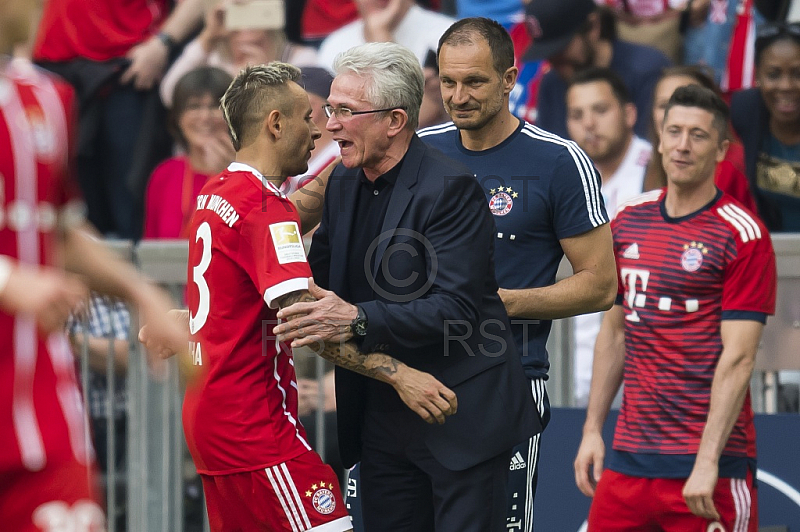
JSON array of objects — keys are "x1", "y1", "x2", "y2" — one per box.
[{"x1": 0, "y1": 58, "x2": 92, "y2": 476}]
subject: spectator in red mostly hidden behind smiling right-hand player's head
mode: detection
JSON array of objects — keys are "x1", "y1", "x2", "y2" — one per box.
[{"x1": 645, "y1": 66, "x2": 756, "y2": 213}]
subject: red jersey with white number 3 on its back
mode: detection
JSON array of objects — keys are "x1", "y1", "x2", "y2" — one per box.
[{"x1": 183, "y1": 163, "x2": 311, "y2": 475}]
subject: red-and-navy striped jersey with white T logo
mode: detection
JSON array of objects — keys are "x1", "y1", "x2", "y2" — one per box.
[{"x1": 611, "y1": 190, "x2": 777, "y2": 457}]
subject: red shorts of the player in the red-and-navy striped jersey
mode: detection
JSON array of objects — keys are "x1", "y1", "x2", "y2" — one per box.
[{"x1": 589, "y1": 469, "x2": 758, "y2": 532}]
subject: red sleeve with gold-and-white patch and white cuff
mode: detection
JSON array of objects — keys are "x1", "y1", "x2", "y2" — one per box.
[{"x1": 242, "y1": 196, "x2": 311, "y2": 308}]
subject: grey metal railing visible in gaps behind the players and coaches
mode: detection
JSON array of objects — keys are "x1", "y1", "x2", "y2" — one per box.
[{"x1": 76, "y1": 234, "x2": 800, "y2": 532}]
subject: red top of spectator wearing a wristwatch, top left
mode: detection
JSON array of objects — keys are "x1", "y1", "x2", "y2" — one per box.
[{"x1": 33, "y1": 0, "x2": 169, "y2": 62}]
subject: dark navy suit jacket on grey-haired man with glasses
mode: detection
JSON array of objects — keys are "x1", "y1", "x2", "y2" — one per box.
[{"x1": 309, "y1": 135, "x2": 541, "y2": 470}]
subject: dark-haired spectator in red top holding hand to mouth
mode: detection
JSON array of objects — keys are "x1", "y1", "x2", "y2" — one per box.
[{"x1": 144, "y1": 67, "x2": 235, "y2": 238}]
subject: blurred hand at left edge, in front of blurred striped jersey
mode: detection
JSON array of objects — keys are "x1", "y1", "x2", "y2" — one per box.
[{"x1": 0, "y1": 265, "x2": 89, "y2": 334}]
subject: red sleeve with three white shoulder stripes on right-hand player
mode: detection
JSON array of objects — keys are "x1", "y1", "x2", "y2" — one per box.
[{"x1": 720, "y1": 203, "x2": 777, "y2": 319}]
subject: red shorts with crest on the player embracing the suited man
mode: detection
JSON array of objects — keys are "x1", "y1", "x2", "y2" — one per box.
[{"x1": 200, "y1": 452, "x2": 352, "y2": 532}]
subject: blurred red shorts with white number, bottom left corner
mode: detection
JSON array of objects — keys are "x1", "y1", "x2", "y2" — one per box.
[{"x1": 0, "y1": 462, "x2": 106, "y2": 532}]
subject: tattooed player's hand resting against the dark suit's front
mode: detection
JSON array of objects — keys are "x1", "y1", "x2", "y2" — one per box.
[{"x1": 392, "y1": 364, "x2": 458, "y2": 425}]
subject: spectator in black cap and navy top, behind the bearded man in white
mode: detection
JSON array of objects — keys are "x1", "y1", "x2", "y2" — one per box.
[{"x1": 524, "y1": 0, "x2": 669, "y2": 137}]
